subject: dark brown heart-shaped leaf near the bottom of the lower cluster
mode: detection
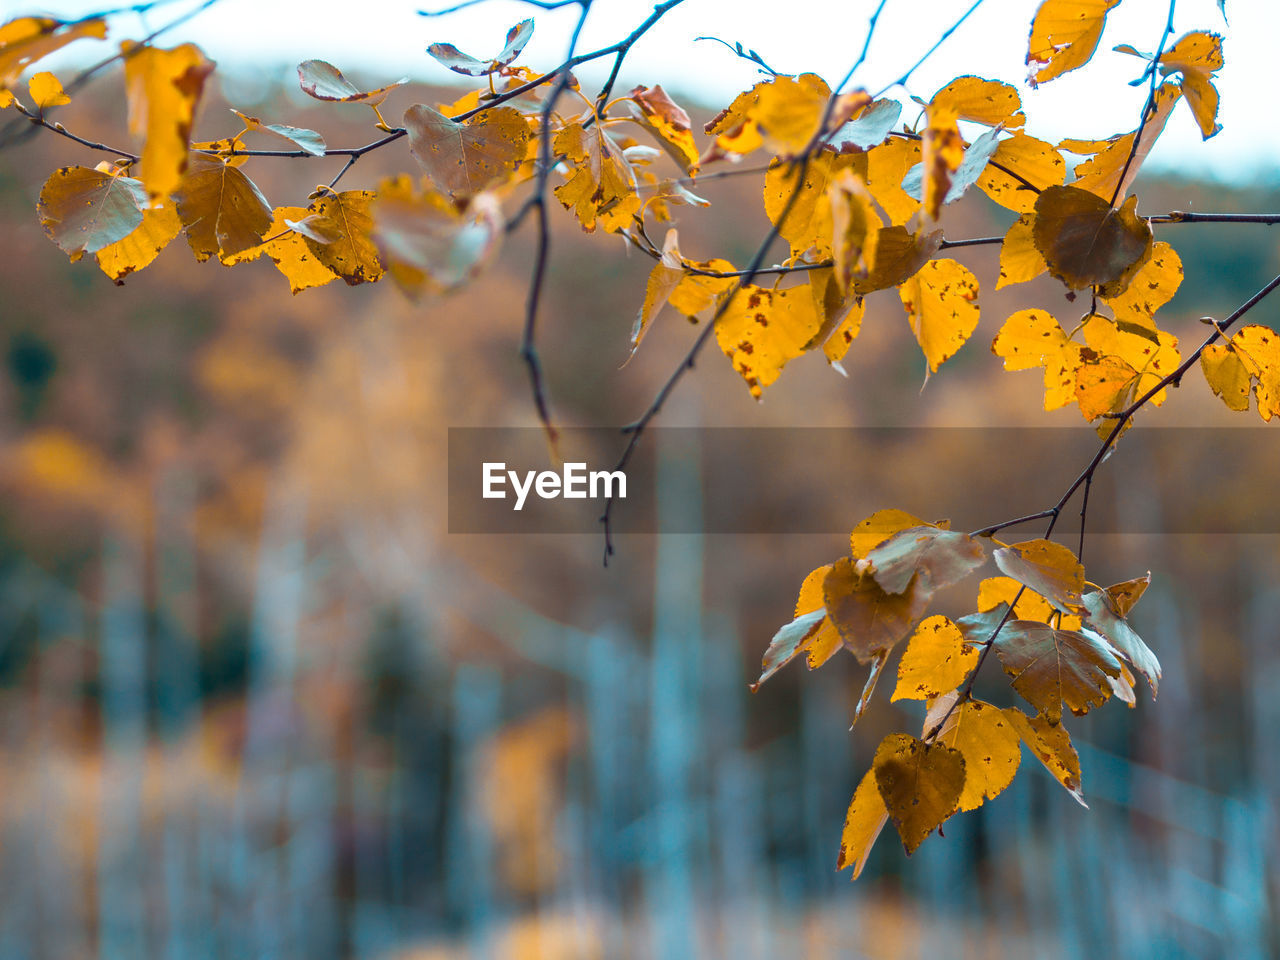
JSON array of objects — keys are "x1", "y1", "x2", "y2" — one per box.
[{"x1": 872, "y1": 733, "x2": 965, "y2": 855}]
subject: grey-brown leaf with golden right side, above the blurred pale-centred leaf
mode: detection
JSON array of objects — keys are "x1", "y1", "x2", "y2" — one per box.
[{"x1": 404, "y1": 104, "x2": 529, "y2": 197}]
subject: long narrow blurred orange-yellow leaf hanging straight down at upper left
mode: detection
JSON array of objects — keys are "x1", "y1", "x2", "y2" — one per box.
[{"x1": 120, "y1": 40, "x2": 215, "y2": 202}]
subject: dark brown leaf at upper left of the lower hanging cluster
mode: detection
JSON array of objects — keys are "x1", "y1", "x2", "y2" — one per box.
[{"x1": 823, "y1": 557, "x2": 928, "y2": 663}]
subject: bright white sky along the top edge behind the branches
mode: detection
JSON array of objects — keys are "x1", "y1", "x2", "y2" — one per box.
[{"x1": 17, "y1": 0, "x2": 1280, "y2": 182}]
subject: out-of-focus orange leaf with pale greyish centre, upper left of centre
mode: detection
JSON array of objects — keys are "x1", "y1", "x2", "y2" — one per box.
[{"x1": 370, "y1": 174, "x2": 503, "y2": 300}]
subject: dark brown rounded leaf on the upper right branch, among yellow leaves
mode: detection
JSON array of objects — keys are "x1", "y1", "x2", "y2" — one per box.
[{"x1": 1032, "y1": 187, "x2": 1153, "y2": 289}]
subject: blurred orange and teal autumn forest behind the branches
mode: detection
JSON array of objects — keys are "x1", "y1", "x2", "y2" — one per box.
[{"x1": 0, "y1": 3, "x2": 1280, "y2": 960}]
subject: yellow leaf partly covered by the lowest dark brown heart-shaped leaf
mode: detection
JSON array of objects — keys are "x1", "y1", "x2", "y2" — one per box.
[{"x1": 924, "y1": 701, "x2": 1023, "y2": 810}]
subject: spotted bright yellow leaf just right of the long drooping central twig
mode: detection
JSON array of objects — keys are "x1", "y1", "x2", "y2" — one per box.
[{"x1": 716, "y1": 284, "x2": 822, "y2": 398}]
